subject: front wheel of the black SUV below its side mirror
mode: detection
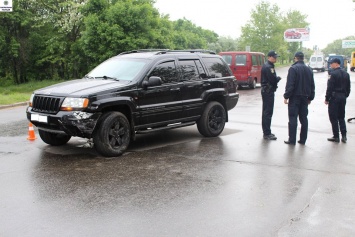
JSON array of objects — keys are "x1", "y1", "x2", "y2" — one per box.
[{"x1": 93, "y1": 112, "x2": 131, "y2": 156}]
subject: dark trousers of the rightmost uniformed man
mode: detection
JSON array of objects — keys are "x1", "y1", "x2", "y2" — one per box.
[{"x1": 328, "y1": 94, "x2": 346, "y2": 137}]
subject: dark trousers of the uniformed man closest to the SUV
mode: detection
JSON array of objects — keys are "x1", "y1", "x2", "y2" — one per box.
[{"x1": 261, "y1": 92, "x2": 275, "y2": 135}]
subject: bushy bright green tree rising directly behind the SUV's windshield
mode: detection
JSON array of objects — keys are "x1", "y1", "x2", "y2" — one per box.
[{"x1": 81, "y1": 0, "x2": 172, "y2": 66}]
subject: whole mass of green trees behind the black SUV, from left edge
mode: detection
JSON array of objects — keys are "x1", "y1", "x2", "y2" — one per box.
[{"x1": 0, "y1": 0, "x2": 222, "y2": 84}]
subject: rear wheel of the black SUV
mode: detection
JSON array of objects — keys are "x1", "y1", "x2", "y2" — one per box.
[{"x1": 197, "y1": 101, "x2": 227, "y2": 137}]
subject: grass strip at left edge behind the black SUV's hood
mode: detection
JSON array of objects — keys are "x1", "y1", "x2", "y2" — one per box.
[{"x1": 0, "y1": 80, "x2": 63, "y2": 105}]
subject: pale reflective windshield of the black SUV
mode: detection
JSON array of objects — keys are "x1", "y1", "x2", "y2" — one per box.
[{"x1": 86, "y1": 58, "x2": 147, "y2": 81}]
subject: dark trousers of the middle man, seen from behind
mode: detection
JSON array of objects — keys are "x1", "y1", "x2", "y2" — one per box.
[{"x1": 288, "y1": 96, "x2": 308, "y2": 143}]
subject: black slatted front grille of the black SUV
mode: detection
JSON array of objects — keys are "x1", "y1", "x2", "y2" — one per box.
[{"x1": 32, "y1": 95, "x2": 63, "y2": 114}]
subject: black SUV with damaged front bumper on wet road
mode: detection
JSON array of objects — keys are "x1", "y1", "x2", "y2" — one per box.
[{"x1": 27, "y1": 50, "x2": 239, "y2": 156}]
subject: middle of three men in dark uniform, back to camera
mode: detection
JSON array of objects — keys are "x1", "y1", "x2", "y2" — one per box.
[{"x1": 284, "y1": 52, "x2": 315, "y2": 145}]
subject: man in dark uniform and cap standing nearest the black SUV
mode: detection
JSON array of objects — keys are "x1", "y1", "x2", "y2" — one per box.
[{"x1": 261, "y1": 51, "x2": 281, "y2": 140}]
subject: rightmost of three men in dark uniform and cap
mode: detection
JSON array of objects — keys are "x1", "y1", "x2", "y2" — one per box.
[{"x1": 324, "y1": 58, "x2": 350, "y2": 143}]
